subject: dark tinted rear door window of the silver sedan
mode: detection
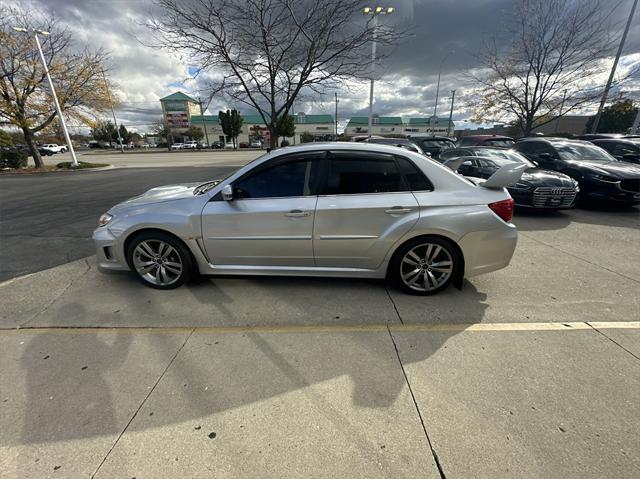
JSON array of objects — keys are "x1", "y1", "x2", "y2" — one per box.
[{"x1": 326, "y1": 154, "x2": 404, "y2": 195}]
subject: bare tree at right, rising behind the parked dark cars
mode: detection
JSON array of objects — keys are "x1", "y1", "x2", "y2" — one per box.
[{"x1": 469, "y1": 0, "x2": 632, "y2": 135}]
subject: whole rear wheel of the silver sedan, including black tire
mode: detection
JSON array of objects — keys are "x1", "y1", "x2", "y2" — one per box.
[{"x1": 388, "y1": 236, "x2": 463, "y2": 296}]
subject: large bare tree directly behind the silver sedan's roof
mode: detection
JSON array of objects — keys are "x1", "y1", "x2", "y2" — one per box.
[{"x1": 150, "y1": 0, "x2": 402, "y2": 147}]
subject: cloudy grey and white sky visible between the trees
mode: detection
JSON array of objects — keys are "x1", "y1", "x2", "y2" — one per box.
[{"x1": 13, "y1": 0, "x2": 640, "y2": 131}]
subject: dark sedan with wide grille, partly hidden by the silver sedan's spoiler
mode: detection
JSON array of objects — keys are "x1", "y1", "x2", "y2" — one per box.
[{"x1": 440, "y1": 146, "x2": 580, "y2": 209}]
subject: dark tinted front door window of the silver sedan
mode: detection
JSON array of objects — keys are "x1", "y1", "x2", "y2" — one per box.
[{"x1": 234, "y1": 160, "x2": 317, "y2": 199}]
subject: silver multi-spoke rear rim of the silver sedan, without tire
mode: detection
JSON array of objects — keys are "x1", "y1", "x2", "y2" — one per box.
[{"x1": 400, "y1": 243, "x2": 453, "y2": 292}]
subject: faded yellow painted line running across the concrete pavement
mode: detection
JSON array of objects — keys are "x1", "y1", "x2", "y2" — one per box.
[{"x1": 0, "y1": 321, "x2": 640, "y2": 335}]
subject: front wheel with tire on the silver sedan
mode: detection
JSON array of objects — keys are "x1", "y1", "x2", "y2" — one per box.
[{"x1": 127, "y1": 231, "x2": 195, "y2": 289}]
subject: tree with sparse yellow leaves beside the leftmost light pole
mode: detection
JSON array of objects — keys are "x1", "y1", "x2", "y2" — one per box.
[{"x1": 0, "y1": 5, "x2": 109, "y2": 167}]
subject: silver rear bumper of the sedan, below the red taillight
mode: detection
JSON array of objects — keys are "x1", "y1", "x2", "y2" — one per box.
[{"x1": 458, "y1": 223, "x2": 518, "y2": 278}]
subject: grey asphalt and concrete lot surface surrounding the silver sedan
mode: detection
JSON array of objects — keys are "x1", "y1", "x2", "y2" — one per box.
[{"x1": 0, "y1": 157, "x2": 640, "y2": 479}]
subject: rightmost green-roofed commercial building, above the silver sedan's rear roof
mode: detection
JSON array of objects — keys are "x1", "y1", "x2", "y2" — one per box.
[{"x1": 345, "y1": 115, "x2": 453, "y2": 136}]
